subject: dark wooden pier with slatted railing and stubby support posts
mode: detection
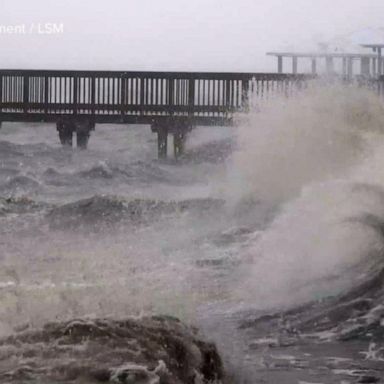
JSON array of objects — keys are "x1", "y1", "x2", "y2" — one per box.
[{"x1": 0, "y1": 70, "x2": 330, "y2": 157}]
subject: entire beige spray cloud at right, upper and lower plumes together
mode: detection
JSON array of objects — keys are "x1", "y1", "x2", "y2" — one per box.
[{"x1": 228, "y1": 84, "x2": 384, "y2": 308}]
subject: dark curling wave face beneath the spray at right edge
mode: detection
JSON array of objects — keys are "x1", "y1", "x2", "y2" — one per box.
[{"x1": 240, "y1": 215, "x2": 384, "y2": 343}]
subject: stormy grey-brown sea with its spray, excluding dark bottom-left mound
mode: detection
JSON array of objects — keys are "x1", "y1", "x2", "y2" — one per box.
[{"x1": 0, "y1": 84, "x2": 384, "y2": 383}]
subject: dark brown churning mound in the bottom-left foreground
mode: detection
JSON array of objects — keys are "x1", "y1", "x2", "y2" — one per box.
[{"x1": 0, "y1": 316, "x2": 223, "y2": 384}]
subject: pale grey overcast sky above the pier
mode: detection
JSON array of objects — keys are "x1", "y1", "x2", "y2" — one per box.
[{"x1": 0, "y1": 0, "x2": 384, "y2": 71}]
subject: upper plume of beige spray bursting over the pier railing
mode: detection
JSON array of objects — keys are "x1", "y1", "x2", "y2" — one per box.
[{"x1": 226, "y1": 83, "x2": 384, "y2": 206}]
